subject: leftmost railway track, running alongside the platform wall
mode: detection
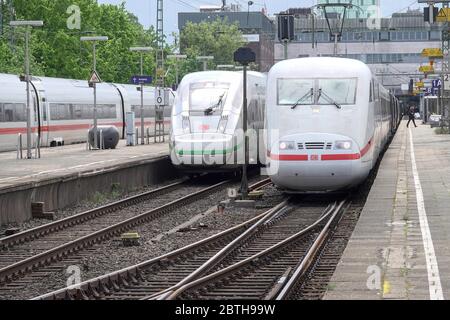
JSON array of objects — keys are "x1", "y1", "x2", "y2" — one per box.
[{"x1": 0, "y1": 176, "x2": 267, "y2": 291}]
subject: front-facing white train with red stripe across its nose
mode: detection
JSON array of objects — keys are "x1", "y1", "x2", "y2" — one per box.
[{"x1": 266, "y1": 57, "x2": 400, "y2": 192}]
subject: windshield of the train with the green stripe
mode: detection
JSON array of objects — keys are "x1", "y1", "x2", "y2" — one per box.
[{"x1": 189, "y1": 82, "x2": 230, "y2": 116}]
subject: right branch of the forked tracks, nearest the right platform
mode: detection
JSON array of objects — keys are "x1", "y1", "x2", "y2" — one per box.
[{"x1": 165, "y1": 201, "x2": 346, "y2": 300}]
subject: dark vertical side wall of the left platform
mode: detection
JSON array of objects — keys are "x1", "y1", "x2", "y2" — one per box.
[{"x1": 0, "y1": 157, "x2": 177, "y2": 225}]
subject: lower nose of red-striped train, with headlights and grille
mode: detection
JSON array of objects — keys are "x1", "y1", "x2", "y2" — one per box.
[{"x1": 270, "y1": 134, "x2": 370, "y2": 191}]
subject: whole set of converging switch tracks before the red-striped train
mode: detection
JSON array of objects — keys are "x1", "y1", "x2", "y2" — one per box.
[{"x1": 36, "y1": 196, "x2": 343, "y2": 300}]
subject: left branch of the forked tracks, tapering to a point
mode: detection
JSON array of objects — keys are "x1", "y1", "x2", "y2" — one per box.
[{"x1": 35, "y1": 205, "x2": 281, "y2": 300}]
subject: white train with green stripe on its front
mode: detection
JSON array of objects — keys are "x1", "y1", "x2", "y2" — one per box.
[{"x1": 170, "y1": 71, "x2": 267, "y2": 173}]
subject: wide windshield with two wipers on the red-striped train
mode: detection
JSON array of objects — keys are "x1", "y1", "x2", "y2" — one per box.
[{"x1": 278, "y1": 78, "x2": 358, "y2": 106}]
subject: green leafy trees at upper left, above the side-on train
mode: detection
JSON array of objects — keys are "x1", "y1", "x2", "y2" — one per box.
[{"x1": 0, "y1": 0, "x2": 156, "y2": 83}]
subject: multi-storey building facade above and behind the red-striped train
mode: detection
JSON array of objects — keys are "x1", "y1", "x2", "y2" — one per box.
[{"x1": 275, "y1": 11, "x2": 441, "y2": 91}]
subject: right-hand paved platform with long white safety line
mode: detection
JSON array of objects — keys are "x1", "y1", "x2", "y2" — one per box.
[{"x1": 324, "y1": 122, "x2": 450, "y2": 300}]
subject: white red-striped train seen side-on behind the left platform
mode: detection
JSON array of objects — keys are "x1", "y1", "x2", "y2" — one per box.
[{"x1": 0, "y1": 74, "x2": 173, "y2": 151}]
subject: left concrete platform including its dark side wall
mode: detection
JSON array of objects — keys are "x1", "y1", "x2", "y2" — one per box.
[{"x1": 0, "y1": 141, "x2": 176, "y2": 225}]
